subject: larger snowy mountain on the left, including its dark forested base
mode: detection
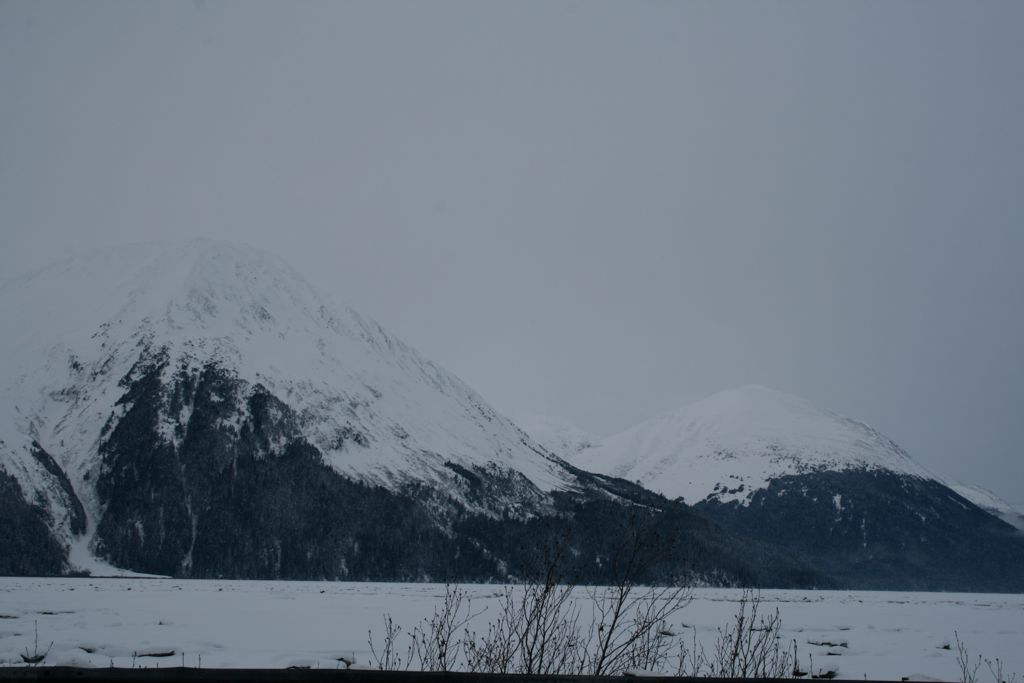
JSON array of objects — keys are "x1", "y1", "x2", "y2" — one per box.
[{"x1": 0, "y1": 240, "x2": 821, "y2": 586}]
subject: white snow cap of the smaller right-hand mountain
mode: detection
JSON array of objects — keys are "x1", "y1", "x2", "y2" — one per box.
[{"x1": 570, "y1": 386, "x2": 931, "y2": 504}]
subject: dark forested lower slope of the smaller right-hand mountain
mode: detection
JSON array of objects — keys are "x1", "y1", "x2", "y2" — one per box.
[{"x1": 695, "y1": 470, "x2": 1024, "y2": 592}]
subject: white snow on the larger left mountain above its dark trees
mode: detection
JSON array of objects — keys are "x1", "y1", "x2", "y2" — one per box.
[{"x1": 0, "y1": 240, "x2": 574, "y2": 561}]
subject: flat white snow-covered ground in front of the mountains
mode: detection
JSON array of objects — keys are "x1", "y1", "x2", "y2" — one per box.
[{"x1": 0, "y1": 578, "x2": 1024, "y2": 683}]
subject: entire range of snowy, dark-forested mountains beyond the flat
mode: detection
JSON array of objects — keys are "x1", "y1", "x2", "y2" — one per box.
[{"x1": 0, "y1": 241, "x2": 1024, "y2": 590}]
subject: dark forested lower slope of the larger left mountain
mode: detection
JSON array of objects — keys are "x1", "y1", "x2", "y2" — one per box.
[{"x1": 28, "y1": 352, "x2": 815, "y2": 586}]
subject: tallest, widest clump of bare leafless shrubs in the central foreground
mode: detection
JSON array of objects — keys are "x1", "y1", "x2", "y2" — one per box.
[{"x1": 369, "y1": 514, "x2": 707, "y2": 676}]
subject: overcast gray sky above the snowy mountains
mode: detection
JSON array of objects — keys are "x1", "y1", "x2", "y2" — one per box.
[{"x1": 0, "y1": 0, "x2": 1024, "y2": 502}]
